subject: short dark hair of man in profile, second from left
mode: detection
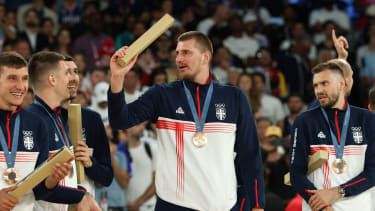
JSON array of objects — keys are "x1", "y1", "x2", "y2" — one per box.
[{"x1": 29, "y1": 51, "x2": 65, "y2": 90}]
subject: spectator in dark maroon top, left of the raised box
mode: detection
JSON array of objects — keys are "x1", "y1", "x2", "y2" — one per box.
[{"x1": 73, "y1": 12, "x2": 112, "y2": 72}]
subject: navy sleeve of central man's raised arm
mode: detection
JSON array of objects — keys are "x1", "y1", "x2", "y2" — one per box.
[{"x1": 108, "y1": 85, "x2": 159, "y2": 129}]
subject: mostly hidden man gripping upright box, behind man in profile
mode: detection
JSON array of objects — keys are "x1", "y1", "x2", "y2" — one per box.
[{"x1": 61, "y1": 56, "x2": 113, "y2": 195}]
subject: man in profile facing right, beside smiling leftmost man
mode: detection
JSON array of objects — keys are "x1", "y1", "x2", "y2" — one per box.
[{"x1": 28, "y1": 51, "x2": 99, "y2": 210}]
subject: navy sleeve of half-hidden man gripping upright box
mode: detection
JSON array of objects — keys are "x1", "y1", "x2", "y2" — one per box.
[{"x1": 85, "y1": 113, "x2": 113, "y2": 186}]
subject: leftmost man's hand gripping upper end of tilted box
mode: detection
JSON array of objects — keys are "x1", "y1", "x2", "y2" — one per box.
[{"x1": 45, "y1": 162, "x2": 72, "y2": 189}]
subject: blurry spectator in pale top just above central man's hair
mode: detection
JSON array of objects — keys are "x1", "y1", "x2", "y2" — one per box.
[{"x1": 197, "y1": 4, "x2": 230, "y2": 35}]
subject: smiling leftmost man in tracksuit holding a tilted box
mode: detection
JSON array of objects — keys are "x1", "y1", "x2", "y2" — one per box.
[{"x1": 0, "y1": 53, "x2": 71, "y2": 211}]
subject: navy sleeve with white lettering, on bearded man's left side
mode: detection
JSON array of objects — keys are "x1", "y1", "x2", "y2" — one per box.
[{"x1": 290, "y1": 116, "x2": 316, "y2": 202}]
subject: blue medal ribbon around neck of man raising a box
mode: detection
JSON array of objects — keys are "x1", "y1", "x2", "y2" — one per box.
[{"x1": 182, "y1": 80, "x2": 213, "y2": 132}]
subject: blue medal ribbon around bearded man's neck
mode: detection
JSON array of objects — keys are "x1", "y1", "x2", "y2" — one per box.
[{"x1": 320, "y1": 104, "x2": 350, "y2": 159}]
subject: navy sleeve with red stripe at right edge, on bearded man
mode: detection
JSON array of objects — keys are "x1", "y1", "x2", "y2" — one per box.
[{"x1": 341, "y1": 113, "x2": 375, "y2": 196}]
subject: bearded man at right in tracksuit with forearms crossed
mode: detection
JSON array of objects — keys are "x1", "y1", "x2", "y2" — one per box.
[{"x1": 290, "y1": 61, "x2": 375, "y2": 211}]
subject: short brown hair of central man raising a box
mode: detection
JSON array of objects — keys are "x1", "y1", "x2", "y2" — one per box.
[{"x1": 177, "y1": 31, "x2": 214, "y2": 55}]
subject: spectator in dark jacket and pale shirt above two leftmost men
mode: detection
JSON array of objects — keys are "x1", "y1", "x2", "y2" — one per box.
[{"x1": 18, "y1": 8, "x2": 49, "y2": 53}]
